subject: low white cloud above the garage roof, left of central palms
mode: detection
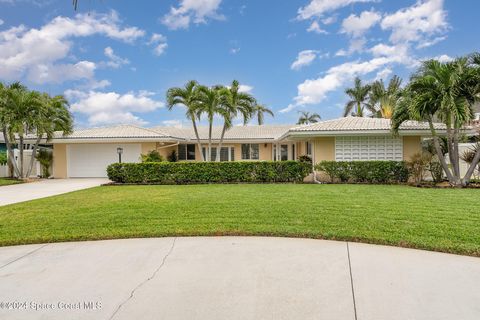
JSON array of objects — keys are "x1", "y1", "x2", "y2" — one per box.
[{"x1": 65, "y1": 90, "x2": 164, "y2": 125}]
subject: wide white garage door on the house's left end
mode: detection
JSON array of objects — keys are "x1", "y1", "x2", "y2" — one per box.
[{"x1": 67, "y1": 143, "x2": 141, "y2": 178}]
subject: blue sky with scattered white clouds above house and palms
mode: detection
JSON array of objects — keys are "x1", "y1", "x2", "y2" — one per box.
[{"x1": 0, "y1": 0, "x2": 480, "y2": 127}]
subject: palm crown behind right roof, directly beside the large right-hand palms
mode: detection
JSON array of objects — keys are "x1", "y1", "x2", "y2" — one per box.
[{"x1": 369, "y1": 75, "x2": 402, "y2": 119}]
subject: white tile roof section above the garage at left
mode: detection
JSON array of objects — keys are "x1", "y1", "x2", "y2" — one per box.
[{"x1": 53, "y1": 125, "x2": 181, "y2": 139}]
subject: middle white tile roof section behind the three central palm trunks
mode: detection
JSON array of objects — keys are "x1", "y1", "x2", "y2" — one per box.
[{"x1": 151, "y1": 125, "x2": 292, "y2": 141}]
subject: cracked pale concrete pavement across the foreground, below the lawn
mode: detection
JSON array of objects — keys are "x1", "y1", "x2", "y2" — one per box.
[{"x1": 0, "y1": 237, "x2": 480, "y2": 320}]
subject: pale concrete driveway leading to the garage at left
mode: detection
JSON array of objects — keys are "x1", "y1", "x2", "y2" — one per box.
[{"x1": 0, "y1": 178, "x2": 109, "y2": 206}]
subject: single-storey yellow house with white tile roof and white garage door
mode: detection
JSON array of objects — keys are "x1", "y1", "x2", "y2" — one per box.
[{"x1": 46, "y1": 117, "x2": 445, "y2": 178}]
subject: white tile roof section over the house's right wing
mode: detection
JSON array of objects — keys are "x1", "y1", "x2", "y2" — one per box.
[{"x1": 289, "y1": 117, "x2": 445, "y2": 132}]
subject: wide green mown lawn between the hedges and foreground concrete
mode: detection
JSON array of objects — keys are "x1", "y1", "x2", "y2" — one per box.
[{"x1": 0, "y1": 184, "x2": 480, "y2": 256}]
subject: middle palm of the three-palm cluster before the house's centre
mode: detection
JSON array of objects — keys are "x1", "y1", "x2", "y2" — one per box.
[{"x1": 197, "y1": 85, "x2": 224, "y2": 161}]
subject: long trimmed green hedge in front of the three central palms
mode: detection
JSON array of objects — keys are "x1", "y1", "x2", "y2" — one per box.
[{"x1": 107, "y1": 161, "x2": 312, "y2": 184}]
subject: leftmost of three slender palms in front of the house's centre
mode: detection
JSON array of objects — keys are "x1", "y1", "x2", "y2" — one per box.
[{"x1": 167, "y1": 80, "x2": 205, "y2": 161}]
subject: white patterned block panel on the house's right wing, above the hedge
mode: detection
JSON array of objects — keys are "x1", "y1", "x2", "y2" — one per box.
[{"x1": 335, "y1": 136, "x2": 403, "y2": 161}]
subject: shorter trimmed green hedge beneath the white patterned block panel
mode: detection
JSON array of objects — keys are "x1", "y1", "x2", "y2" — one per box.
[{"x1": 315, "y1": 161, "x2": 410, "y2": 184}]
